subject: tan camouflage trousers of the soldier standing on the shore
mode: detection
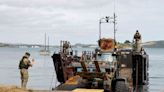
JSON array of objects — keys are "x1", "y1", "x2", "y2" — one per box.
[{"x1": 20, "y1": 69, "x2": 29, "y2": 89}]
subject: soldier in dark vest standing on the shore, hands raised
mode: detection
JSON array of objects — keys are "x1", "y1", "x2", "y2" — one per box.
[{"x1": 19, "y1": 52, "x2": 34, "y2": 89}]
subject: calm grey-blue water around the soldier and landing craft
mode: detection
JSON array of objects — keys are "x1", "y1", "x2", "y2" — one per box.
[{"x1": 0, "y1": 48, "x2": 164, "y2": 92}]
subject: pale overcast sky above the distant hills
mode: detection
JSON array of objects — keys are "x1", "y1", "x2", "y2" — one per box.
[{"x1": 0, "y1": 0, "x2": 164, "y2": 45}]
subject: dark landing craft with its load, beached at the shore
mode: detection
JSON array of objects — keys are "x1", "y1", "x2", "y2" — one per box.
[{"x1": 52, "y1": 14, "x2": 149, "y2": 92}]
